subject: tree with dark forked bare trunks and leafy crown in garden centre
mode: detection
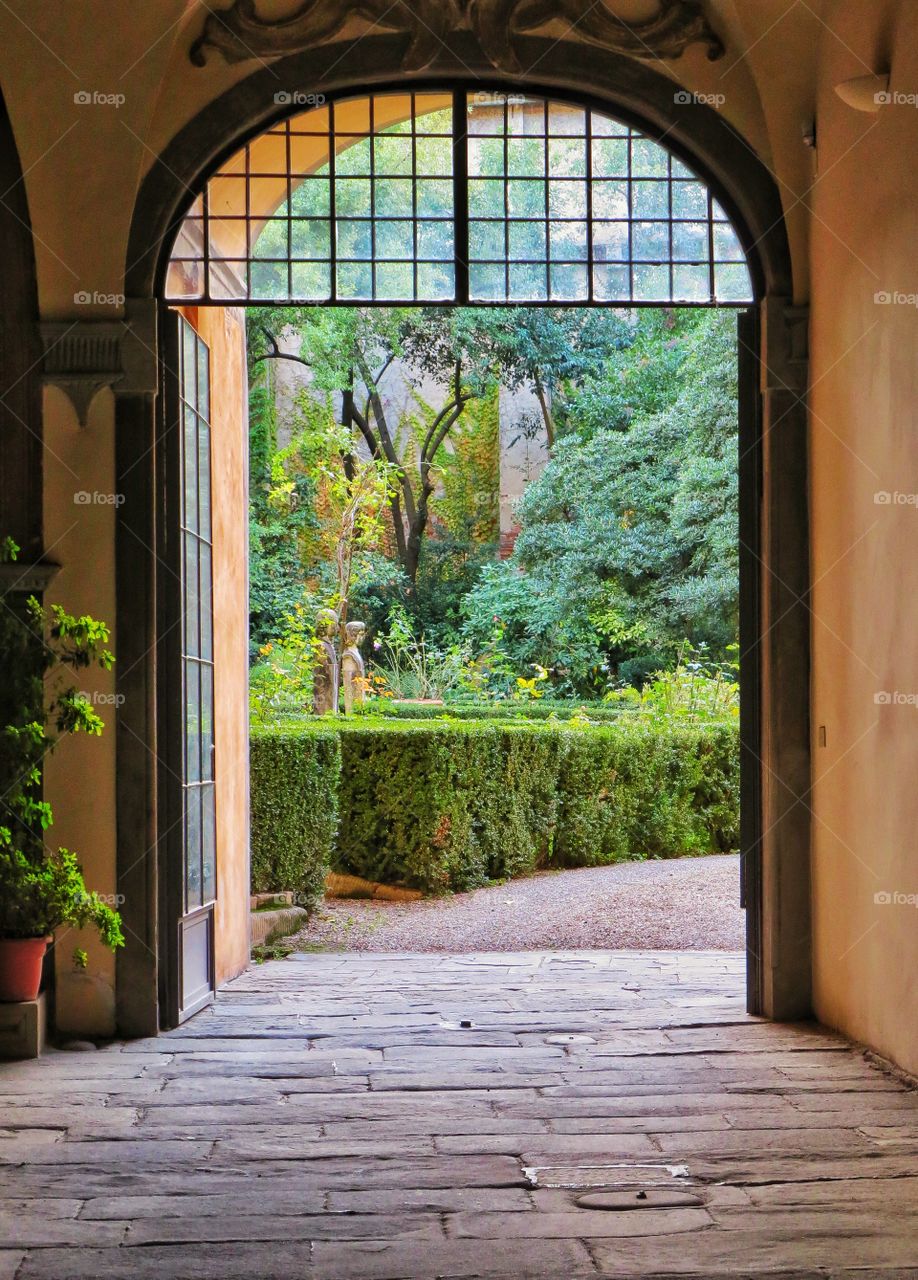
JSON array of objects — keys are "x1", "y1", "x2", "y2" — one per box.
[{"x1": 252, "y1": 307, "x2": 626, "y2": 585}]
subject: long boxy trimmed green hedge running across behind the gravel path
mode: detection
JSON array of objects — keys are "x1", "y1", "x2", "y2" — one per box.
[{"x1": 252, "y1": 717, "x2": 739, "y2": 893}]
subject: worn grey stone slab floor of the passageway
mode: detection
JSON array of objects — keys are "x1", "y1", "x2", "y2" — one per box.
[{"x1": 0, "y1": 952, "x2": 918, "y2": 1280}]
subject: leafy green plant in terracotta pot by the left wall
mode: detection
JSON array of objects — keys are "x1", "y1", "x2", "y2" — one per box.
[{"x1": 0, "y1": 539, "x2": 124, "y2": 1001}]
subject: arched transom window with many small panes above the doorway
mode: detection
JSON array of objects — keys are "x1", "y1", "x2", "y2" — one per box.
[{"x1": 166, "y1": 91, "x2": 753, "y2": 306}]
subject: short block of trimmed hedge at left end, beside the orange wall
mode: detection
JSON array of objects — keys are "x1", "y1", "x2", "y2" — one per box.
[{"x1": 250, "y1": 724, "x2": 341, "y2": 906}]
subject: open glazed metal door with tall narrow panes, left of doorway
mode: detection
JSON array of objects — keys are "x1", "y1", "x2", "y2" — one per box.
[{"x1": 160, "y1": 311, "x2": 218, "y2": 1027}]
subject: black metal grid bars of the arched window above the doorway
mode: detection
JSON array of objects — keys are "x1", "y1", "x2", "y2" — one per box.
[{"x1": 166, "y1": 84, "x2": 755, "y2": 310}]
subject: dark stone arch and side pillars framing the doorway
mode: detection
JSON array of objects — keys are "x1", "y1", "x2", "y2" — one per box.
[{"x1": 117, "y1": 32, "x2": 810, "y2": 1033}]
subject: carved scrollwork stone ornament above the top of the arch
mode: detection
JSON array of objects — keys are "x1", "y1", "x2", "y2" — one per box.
[{"x1": 189, "y1": 0, "x2": 723, "y2": 73}]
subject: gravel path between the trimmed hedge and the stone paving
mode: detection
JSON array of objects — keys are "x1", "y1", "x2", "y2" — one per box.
[{"x1": 284, "y1": 854, "x2": 744, "y2": 952}]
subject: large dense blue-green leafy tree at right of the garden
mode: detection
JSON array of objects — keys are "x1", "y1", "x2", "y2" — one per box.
[{"x1": 463, "y1": 312, "x2": 739, "y2": 696}]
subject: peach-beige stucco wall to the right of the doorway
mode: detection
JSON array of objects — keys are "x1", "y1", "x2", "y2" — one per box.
[{"x1": 810, "y1": 0, "x2": 918, "y2": 1073}]
